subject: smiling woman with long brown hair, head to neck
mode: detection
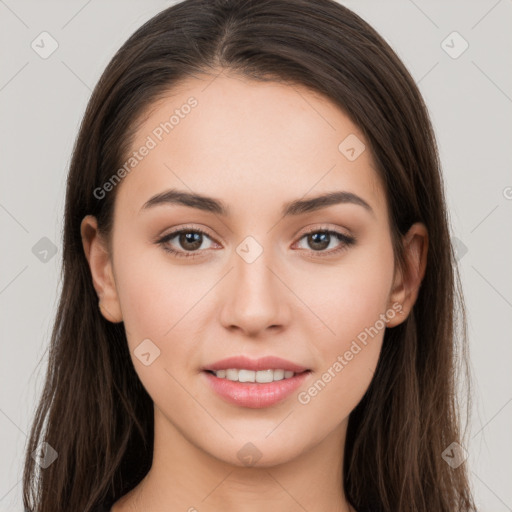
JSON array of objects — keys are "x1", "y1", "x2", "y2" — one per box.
[{"x1": 24, "y1": 0, "x2": 475, "y2": 512}]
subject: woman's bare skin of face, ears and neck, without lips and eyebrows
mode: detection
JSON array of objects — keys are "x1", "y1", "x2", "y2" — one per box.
[{"x1": 81, "y1": 71, "x2": 427, "y2": 512}]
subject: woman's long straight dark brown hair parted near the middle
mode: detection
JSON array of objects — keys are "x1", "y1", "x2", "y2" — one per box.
[{"x1": 23, "y1": 0, "x2": 476, "y2": 512}]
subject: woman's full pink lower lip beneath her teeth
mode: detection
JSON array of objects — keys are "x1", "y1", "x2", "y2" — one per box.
[{"x1": 202, "y1": 371, "x2": 311, "y2": 409}]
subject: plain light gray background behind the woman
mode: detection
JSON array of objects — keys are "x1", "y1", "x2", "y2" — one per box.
[{"x1": 0, "y1": 0, "x2": 512, "y2": 512}]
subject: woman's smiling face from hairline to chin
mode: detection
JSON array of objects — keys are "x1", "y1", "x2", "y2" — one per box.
[{"x1": 82, "y1": 73, "x2": 414, "y2": 466}]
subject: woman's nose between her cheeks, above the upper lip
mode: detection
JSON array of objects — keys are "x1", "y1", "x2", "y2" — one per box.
[{"x1": 221, "y1": 240, "x2": 292, "y2": 337}]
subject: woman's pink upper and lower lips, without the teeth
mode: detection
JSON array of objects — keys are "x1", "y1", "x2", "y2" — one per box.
[{"x1": 202, "y1": 356, "x2": 311, "y2": 409}]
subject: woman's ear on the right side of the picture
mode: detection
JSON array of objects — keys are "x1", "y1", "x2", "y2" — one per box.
[{"x1": 387, "y1": 222, "x2": 428, "y2": 327}]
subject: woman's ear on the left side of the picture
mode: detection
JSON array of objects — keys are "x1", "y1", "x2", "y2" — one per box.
[{"x1": 80, "y1": 215, "x2": 123, "y2": 323}]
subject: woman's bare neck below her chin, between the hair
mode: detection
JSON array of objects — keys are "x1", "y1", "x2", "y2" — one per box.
[{"x1": 112, "y1": 407, "x2": 355, "y2": 512}]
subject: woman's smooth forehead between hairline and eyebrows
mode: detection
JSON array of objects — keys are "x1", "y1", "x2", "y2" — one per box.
[{"x1": 116, "y1": 73, "x2": 386, "y2": 222}]
